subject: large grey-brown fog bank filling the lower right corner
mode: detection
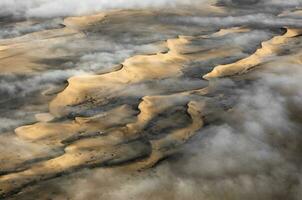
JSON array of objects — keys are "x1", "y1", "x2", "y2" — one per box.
[{"x1": 47, "y1": 63, "x2": 302, "y2": 200}]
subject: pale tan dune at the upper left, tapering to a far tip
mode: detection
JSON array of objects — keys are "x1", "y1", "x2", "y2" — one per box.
[{"x1": 0, "y1": 13, "x2": 106, "y2": 74}]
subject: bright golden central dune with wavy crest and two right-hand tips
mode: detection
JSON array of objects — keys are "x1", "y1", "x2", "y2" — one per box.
[{"x1": 49, "y1": 29, "x2": 247, "y2": 117}]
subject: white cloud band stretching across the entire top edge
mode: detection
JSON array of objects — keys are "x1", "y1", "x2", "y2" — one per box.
[{"x1": 0, "y1": 0, "x2": 302, "y2": 18}]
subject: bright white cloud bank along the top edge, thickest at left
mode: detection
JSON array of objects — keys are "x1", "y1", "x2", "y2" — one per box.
[{"x1": 0, "y1": 0, "x2": 210, "y2": 18}]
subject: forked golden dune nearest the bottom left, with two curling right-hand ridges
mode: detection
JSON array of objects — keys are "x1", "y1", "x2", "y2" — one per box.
[{"x1": 0, "y1": 89, "x2": 205, "y2": 197}]
